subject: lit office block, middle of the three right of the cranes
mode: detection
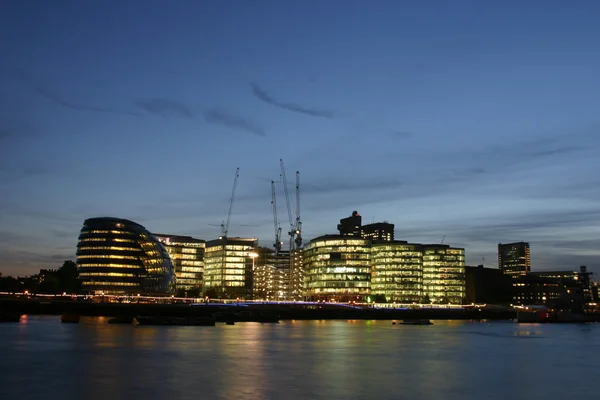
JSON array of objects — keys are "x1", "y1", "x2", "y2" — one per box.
[{"x1": 371, "y1": 241, "x2": 423, "y2": 303}]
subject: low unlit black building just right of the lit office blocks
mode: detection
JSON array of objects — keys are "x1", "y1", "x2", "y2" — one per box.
[{"x1": 465, "y1": 265, "x2": 512, "y2": 304}]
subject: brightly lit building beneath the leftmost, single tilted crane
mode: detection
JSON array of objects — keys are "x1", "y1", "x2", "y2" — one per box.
[{"x1": 203, "y1": 238, "x2": 257, "y2": 300}]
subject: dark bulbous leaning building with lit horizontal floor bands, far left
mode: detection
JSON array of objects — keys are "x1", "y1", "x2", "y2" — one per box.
[{"x1": 77, "y1": 217, "x2": 175, "y2": 295}]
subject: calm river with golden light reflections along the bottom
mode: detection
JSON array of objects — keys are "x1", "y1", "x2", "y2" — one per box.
[{"x1": 0, "y1": 316, "x2": 600, "y2": 400}]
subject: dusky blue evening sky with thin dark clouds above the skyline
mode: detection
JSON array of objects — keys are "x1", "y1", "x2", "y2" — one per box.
[{"x1": 0, "y1": 0, "x2": 600, "y2": 275}]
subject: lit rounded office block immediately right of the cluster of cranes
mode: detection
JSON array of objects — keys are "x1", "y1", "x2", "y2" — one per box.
[{"x1": 304, "y1": 235, "x2": 371, "y2": 302}]
